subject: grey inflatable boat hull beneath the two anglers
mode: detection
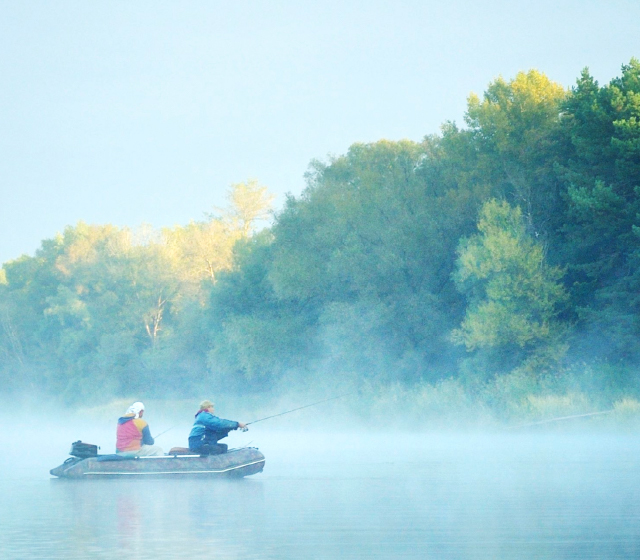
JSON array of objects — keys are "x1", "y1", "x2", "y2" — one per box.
[{"x1": 49, "y1": 447, "x2": 265, "y2": 479}]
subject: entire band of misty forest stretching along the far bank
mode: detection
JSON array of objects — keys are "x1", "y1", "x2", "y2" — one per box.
[{"x1": 0, "y1": 59, "x2": 640, "y2": 420}]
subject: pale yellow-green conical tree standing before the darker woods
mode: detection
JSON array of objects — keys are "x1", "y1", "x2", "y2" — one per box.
[{"x1": 453, "y1": 200, "x2": 566, "y2": 370}]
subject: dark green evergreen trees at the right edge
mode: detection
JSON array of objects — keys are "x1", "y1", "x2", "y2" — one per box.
[{"x1": 558, "y1": 59, "x2": 640, "y2": 363}]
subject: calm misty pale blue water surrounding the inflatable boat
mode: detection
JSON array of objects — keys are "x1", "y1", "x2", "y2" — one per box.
[{"x1": 0, "y1": 430, "x2": 640, "y2": 560}]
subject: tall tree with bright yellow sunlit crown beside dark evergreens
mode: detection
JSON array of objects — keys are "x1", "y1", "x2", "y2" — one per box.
[{"x1": 465, "y1": 70, "x2": 567, "y2": 239}]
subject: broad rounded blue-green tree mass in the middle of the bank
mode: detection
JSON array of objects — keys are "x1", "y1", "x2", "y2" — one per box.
[{"x1": 262, "y1": 139, "x2": 483, "y2": 379}]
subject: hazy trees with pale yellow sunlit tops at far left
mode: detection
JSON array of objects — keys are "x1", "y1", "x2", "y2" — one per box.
[{"x1": 0, "y1": 183, "x2": 268, "y2": 401}]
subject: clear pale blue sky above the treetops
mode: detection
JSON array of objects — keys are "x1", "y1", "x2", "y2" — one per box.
[{"x1": 0, "y1": 0, "x2": 640, "y2": 263}]
